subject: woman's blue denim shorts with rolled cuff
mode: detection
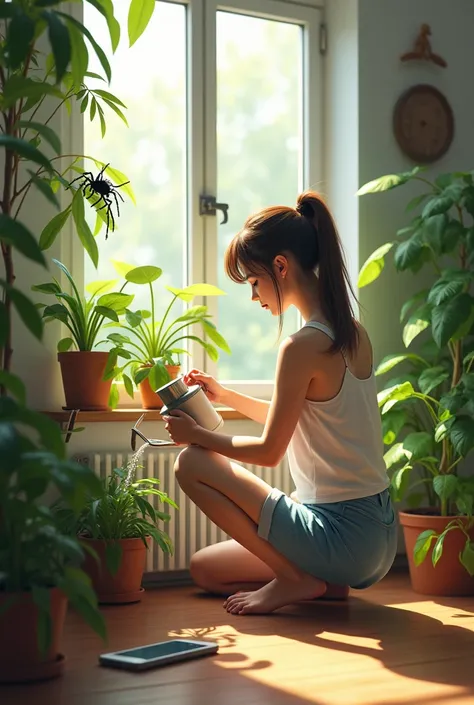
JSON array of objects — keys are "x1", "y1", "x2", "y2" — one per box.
[{"x1": 258, "y1": 488, "x2": 398, "y2": 589}]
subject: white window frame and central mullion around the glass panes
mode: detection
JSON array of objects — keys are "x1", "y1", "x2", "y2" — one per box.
[{"x1": 74, "y1": 0, "x2": 324, "y2": 408}]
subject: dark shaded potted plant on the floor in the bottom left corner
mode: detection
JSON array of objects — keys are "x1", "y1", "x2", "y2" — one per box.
[{"x1": 0, "y1": 396, "x2": 105, "y2": 683}]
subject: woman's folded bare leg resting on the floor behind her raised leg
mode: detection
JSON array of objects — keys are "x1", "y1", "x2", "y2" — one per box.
[{"x1": 190, "y1": 539, "x2": 349, "y2": 600}]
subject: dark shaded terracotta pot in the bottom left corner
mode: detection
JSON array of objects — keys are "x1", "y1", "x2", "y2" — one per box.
[{"x1": 0, "y1": 588, "x2": 67, "y2": 683}]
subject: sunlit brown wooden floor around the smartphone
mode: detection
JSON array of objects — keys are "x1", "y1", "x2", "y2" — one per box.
[{"x1": 0, "y1": 574, "x2": 474, "y2": 705}]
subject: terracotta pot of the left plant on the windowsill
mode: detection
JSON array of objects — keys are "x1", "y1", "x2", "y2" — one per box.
[{"x1": 58, "y1": 351, "x2": 112, "y2": 411}]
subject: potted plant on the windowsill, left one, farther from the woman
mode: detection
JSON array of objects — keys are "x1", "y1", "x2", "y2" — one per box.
[{"x1": 32, "y1": 259, "x2": 134, "y2": 409}]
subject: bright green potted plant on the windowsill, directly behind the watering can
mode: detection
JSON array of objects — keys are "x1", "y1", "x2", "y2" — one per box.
[{"x1": 107, "y1": 263, "x2": 230, "y2": 409}]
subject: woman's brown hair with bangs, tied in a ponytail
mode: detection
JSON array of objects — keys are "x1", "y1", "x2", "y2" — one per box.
[{"x1": 224, "y1": 191, "x2": 358, "y2": 352}]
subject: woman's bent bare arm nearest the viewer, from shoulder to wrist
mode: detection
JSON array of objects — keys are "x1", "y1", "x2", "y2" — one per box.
[{"x1": 189, "y1": 336, "x2": 315, "y2": 467}]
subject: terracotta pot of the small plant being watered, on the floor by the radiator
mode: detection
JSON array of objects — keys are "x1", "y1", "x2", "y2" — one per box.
[{"x1": 81, "y1": 537, "x2": 151, "y2": 605}]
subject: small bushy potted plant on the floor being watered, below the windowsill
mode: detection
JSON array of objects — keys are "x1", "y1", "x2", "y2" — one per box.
[{"x1": 56, "y1": 455, "x2": 177, "y2": 604}]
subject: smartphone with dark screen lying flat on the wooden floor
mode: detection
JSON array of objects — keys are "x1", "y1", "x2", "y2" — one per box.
[{"x1": 99, "y1": 639, "x2": 219, "y2": 671}]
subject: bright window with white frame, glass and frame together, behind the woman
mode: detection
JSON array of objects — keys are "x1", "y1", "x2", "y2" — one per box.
[{"x1": 84, "y1": 0, "x2": 322, "y2": 396}]
